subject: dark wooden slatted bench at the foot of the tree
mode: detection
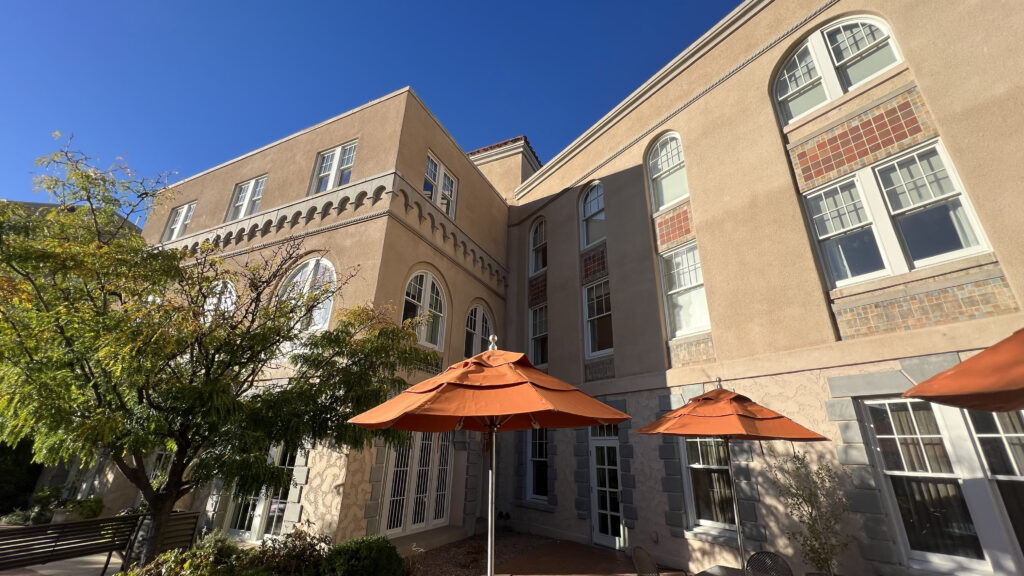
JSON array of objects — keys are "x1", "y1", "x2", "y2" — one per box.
[{"x1": 0, "y1": 512, "x2": 199, "y2": 575}]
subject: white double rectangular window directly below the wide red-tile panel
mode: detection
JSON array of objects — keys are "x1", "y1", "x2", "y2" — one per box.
[{"x1": 804, "y1": 142, "x2": 985, "y2": 287}]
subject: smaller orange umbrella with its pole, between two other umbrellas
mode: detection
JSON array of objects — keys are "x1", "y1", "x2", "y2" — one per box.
[{"x1": 637, "y1": 388, "x2": 828, "y2": 568}]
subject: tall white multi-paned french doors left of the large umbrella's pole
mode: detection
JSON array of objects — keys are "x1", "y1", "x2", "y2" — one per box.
[{"x1": 382, "y1": 431, "x2": 454, "y2": 535}]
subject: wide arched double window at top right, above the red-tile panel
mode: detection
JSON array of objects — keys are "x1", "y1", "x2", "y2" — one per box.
[{"x1": 774, "y1": 16, "x2": 902, "y2": 124}]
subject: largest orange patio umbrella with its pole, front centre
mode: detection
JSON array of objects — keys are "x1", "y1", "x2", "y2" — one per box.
[{"x1": 349, "y1": 336, "x2": 630, "y2": 576}]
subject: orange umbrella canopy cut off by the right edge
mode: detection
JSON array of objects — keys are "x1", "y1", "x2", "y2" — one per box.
[{"x1": 903, "y1": 330, "x2": 1024, "y2": 412}]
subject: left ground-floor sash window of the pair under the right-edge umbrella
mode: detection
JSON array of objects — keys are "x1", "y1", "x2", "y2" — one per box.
[{"x1": 865, "y1": 400, "x2": 984, "y2": 560}]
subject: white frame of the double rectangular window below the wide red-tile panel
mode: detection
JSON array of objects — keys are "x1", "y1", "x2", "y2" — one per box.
[{"x1": 801, "y1": 138, "x2": 991, "y2": 288}]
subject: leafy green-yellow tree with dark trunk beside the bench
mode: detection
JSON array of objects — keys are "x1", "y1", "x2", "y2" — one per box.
[{"x1": 0, "y1": 147, "x2": 436, "y2": 561}]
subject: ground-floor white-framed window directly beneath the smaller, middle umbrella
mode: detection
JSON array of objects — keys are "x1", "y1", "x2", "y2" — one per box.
[{"x1": 684, "y1": 438, "x2": 736, "y2": 529}]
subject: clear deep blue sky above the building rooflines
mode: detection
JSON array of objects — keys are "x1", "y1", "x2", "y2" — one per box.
[{"x1": 0, "y1": 0, "x2": 738, "y2": 200}]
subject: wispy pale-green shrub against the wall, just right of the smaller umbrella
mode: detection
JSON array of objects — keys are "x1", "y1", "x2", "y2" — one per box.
[{"x1": 768, "y1": 450, "x2": 851, "y2": 576}]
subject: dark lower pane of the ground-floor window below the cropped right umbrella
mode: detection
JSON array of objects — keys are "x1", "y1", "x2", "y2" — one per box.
[{"x1": 889, "y1": 476, "x2": 983, "y2": 559}]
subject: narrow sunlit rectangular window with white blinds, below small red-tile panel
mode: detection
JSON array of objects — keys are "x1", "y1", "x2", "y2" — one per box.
[{"x1": 662, "y1": 242, "x2": 711, "y2": 337}]
